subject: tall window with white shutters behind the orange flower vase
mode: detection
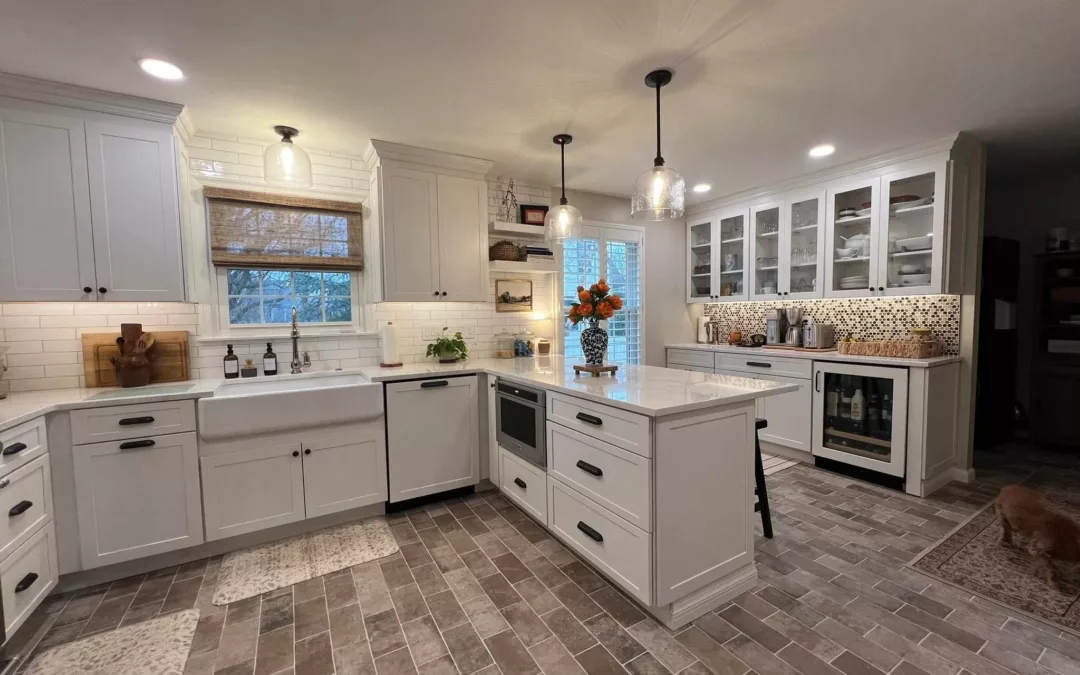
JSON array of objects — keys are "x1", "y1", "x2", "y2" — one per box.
[{"x1": 563, "y1": 225, "x2": 644, "y2": 364}]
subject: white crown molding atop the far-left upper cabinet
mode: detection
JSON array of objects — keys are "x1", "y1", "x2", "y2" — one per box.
[{"x1": 0, "y1": 72, "x2": 184, "y2": 124}]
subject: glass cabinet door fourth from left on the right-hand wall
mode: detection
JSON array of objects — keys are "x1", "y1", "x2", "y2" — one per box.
[{"x1": 780, "y1": 191, "x2": 825, "y2": 298}]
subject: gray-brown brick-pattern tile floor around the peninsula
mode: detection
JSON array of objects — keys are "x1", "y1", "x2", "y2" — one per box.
[{"x1": 19, "y1": 453, "x2": 1080, "y2": 675}]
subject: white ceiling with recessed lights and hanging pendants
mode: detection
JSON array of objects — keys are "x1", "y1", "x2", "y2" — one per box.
[{"x1": 0, "y1": 0, "x2": 1080, "y2": 197}]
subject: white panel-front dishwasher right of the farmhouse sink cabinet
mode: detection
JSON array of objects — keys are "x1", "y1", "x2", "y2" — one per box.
[{"x1": 386, "y1": 375, "x2": 480, "y2": 502}]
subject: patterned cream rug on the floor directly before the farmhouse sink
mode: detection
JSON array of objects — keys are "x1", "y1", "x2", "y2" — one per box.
[{"x1": 212, "y1": 517, "x2": 397, "y2": 605}]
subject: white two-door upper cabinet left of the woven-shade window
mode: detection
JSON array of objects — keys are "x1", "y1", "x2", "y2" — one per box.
[{"x1": 0, "y1": 100, "x2": 184, "y2": 301}]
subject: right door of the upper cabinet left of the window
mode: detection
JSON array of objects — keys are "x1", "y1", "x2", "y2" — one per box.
[{"x1": 86, "y1": 122, "x2": 184, "y2": 301}]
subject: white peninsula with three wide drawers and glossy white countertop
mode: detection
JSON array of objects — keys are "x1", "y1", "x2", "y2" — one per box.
[{"x1": 362, "y1": 355, "x2": 796, "y2": 629}]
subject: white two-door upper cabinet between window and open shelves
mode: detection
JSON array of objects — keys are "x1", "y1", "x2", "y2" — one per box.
[{"x1": 366, "y1": 140, "x2": 491, "y2": 302}]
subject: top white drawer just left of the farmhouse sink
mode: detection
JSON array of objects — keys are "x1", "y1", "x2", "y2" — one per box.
[{"x1": 71, "y1": 401, "x2": 195, "y2": 445}]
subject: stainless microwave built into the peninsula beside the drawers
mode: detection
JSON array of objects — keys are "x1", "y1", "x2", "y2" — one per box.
[{"x1": 495, "y1": 378, "x2": 548, "y2": 469}]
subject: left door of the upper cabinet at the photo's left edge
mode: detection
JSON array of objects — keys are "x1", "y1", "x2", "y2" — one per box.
[{"x1": 0, "y1": 110, "x2": 96, "y2": 301}]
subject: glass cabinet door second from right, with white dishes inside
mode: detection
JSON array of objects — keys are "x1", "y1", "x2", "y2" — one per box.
[{"x1": 825, "y1": 178, "x2": 880, "y2": 298}]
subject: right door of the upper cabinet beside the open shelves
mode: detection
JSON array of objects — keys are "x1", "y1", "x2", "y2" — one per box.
[{"x1": 438, "y1": 176, "x2": 488, "y2": 302}]
